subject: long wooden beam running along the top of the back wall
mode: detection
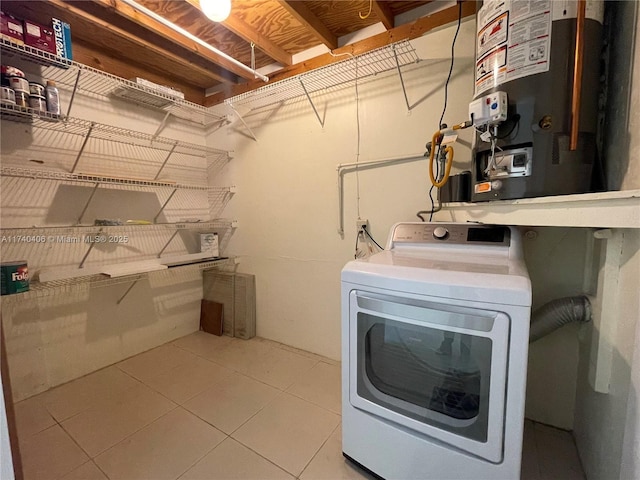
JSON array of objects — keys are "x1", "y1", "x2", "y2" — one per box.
[{"x1": 205, "y1": 1, "x2": 476, "y2": 107}]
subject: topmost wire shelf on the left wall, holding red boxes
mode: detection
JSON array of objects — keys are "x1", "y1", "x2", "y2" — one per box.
[{"x1": 0, "y1": 39, "x2": 226, "y2": 127}]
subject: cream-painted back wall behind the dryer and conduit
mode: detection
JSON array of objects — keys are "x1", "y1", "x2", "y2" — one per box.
[{"x1": 211, "y1": 20, "x2": 475, "y2": 359}]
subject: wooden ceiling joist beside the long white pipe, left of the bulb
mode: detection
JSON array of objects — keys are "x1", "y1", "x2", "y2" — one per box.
[{"x1": 93, "y1": 0, "x2": 254, "y2": 83}]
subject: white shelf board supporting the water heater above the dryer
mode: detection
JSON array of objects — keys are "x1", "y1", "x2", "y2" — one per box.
[{"x1": 436, "y1": 190, "x2": 640, "y2": 228}]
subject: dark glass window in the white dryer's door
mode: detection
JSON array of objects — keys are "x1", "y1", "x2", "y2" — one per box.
[{"x1": 357, "y1": 312, "x2": 492, "y2": 442}]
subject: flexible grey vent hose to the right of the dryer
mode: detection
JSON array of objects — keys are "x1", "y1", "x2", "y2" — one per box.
[{"x1": 529, "y1": 295, "x2": 591, "y2": 343}]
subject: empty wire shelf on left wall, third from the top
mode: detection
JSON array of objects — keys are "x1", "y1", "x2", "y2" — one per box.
[{"x1": 0, "y1": 166, "x2": 235, "y2": 192}]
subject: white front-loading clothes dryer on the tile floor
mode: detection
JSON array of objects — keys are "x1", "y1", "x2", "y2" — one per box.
[{"x1": 342, "y1": 223, "x2": 531, "y2": 480}]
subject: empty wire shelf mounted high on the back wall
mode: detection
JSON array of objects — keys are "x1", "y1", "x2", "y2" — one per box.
[{"x1": 225, "y1": 40, "x2": 420, "y2": 110}]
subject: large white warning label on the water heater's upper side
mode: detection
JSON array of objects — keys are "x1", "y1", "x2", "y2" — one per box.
[{"x1": 475, "y1": 0, "x2": 552, "y2": 96}]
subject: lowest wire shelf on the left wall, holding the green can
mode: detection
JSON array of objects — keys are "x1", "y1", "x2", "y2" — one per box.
[{"x1": 2, "y1": 257, "x2": 235, "y2": 303}]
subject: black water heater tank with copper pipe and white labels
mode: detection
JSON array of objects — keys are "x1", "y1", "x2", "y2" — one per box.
[{"x1": 469, "y1": 0, "x2": 604, "y2": 201}]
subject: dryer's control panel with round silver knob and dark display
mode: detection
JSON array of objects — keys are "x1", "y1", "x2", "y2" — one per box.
[{"x1": 391, "y1": 223, "x2": 511, "y2": 247}]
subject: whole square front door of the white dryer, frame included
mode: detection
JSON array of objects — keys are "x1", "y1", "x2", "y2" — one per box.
[{"x1": 349, "y1": 291, "x2": 509, "y2": 463}]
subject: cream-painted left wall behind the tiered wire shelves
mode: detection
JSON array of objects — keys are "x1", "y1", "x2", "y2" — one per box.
[{"x1": 0, "y1": 62, "x2": 209, "y2": 402}]
